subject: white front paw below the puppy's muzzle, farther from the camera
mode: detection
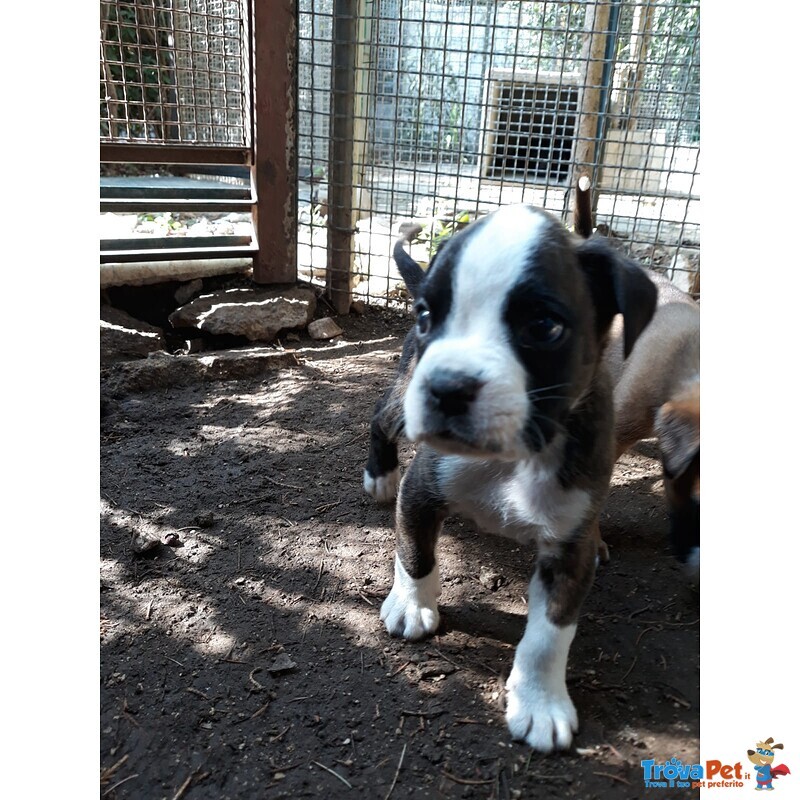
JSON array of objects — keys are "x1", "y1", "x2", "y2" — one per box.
[{"x1": 381, "y1": 556, "x2": 442, "y2": 639}]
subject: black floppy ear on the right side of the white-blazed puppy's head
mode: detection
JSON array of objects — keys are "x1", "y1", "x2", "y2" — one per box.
[{"x1": 576, "y1": 238, "x2": 658, "y2": 358}]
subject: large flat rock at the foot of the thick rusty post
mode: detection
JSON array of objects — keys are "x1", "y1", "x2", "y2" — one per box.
[{"x1": 169, "y1": 287, "x2": 317, "y2": 342}]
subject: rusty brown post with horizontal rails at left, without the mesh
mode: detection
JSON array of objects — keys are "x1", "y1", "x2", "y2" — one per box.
[{"x1": 100, "y1": 0, "x2": 297, "y2": 284}]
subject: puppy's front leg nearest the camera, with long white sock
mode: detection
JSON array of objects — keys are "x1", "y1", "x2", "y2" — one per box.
[{"x1": 506, "y1": 532, "x2": 596, "y2": 752}]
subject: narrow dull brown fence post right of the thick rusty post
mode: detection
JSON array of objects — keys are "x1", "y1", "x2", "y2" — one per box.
[{"x1": 326, "y1": 0, "x2": 359, "y2": 314}]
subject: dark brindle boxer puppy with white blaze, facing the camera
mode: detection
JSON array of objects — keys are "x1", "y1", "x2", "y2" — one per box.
[{"x1": 364, "y1": 206, "x2": 656, "y2": 752}]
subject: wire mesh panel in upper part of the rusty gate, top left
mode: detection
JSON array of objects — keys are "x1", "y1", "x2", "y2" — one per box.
[{"x1": 100, "y1": 0, "x2": 252, "y2": 147}]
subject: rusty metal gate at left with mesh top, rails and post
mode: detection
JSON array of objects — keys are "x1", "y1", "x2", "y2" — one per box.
[{"x1": 100, "y1": 0, "x2": 296, "y2": 282}]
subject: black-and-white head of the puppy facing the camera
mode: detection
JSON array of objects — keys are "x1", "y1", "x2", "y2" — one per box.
[{"x1": 395, "y1": 206, "x2": 656, "y2": 460}]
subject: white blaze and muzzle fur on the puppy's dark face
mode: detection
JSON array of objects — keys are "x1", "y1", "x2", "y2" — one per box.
[{"x1": 404, "y1": 206, "x2": 549, "y2": 458}]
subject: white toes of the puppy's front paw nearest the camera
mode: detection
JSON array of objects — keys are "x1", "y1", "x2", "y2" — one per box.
[{"x1": 506, "y1": 665, "x2": 578, "y2": 753}]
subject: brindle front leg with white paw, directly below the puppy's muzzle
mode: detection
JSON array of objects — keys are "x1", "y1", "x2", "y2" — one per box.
[{"x1": 381, "y1": 450, "x2": 444, "y2": 639}]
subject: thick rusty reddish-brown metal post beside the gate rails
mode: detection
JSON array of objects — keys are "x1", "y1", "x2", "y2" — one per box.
[{"x1": 251, "y1": 0, "x2": 297, "y2": 283}]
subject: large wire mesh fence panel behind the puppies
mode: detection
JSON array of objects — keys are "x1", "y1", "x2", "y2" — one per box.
[{"x1": 298, "y1": 0, "x2": 699, "y2": 303}]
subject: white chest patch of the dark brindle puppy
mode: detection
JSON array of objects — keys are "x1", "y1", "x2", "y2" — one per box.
[{"x1": 439, "y1": 456, "x2": 591, "y2": 542}]
